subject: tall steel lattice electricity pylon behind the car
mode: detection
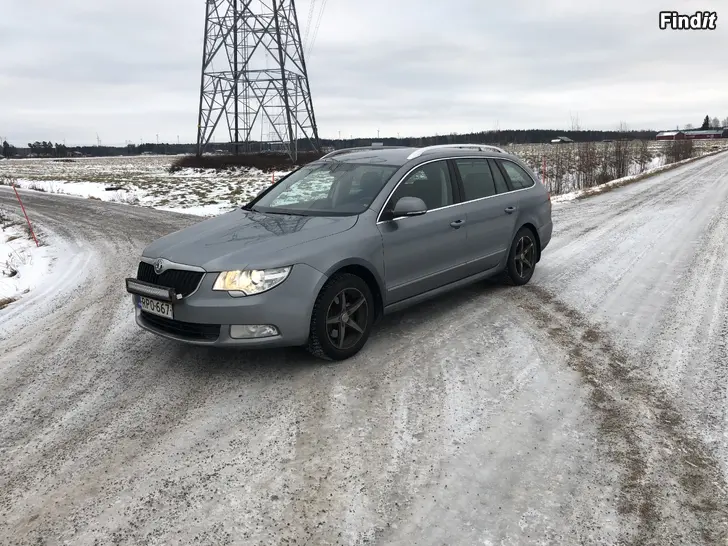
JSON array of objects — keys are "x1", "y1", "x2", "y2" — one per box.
[{"x1": 197, "y1": 0, "x2": 320, "y2": 161}]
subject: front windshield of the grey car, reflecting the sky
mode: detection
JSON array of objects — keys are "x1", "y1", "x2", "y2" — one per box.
[{"x1": 247, "y1": 161, "x2": 397, "y2": 216}]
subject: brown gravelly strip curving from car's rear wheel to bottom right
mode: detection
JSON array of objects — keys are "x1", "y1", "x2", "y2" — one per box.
[{"x1": 513, "y1": 286, "x2": 728, "y2": 545}]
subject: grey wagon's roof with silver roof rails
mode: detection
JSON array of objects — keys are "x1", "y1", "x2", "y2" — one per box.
[{"x1": 319, "y1": 144, "x2": 514, "y2": 167}]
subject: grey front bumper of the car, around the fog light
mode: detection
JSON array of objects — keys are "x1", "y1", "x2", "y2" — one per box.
[{"x1": 132, "y1": 264, "x2": 326, "y2": 348}]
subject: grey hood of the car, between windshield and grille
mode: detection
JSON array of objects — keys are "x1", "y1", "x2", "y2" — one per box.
[{"x1": 143, "y1": 209, "x2": 358, "y2": 271}]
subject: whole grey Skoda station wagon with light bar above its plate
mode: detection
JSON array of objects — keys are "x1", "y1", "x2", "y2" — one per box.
[{"x1": 126, "y1": 144, "x2": 552, "y2": 360}]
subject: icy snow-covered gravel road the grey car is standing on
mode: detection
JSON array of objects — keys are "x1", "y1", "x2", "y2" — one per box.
[{"x1": 0, "y1": 150, "x2": 728, "y2": 546}]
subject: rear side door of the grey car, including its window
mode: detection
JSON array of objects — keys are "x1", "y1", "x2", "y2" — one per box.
[{"x1": 452, "y1": 157, "x2": 518, "y2": 274}]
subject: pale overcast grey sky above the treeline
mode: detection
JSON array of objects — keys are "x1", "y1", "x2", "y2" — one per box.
[{"x1": 0, "y1": 0, "x2": 728, "y2": 146}]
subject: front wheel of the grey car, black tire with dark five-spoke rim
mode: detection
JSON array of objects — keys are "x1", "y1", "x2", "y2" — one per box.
[{"x1": 307, "y1": 273, "x2": 374, "y2": 360}]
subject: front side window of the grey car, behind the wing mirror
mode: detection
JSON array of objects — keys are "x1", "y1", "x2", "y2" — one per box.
[{"x1": 385, "y1": 160, "x2": 454, "y2": 211}]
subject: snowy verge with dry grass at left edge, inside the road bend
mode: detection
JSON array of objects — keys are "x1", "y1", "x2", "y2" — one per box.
[{"x1": 0, "y1": 209, "x2": 55, "y2": 311}]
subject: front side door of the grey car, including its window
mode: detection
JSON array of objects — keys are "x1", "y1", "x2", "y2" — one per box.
[{"x1": 377, "y1": 160, "x2": 466, "y2": 305}]
